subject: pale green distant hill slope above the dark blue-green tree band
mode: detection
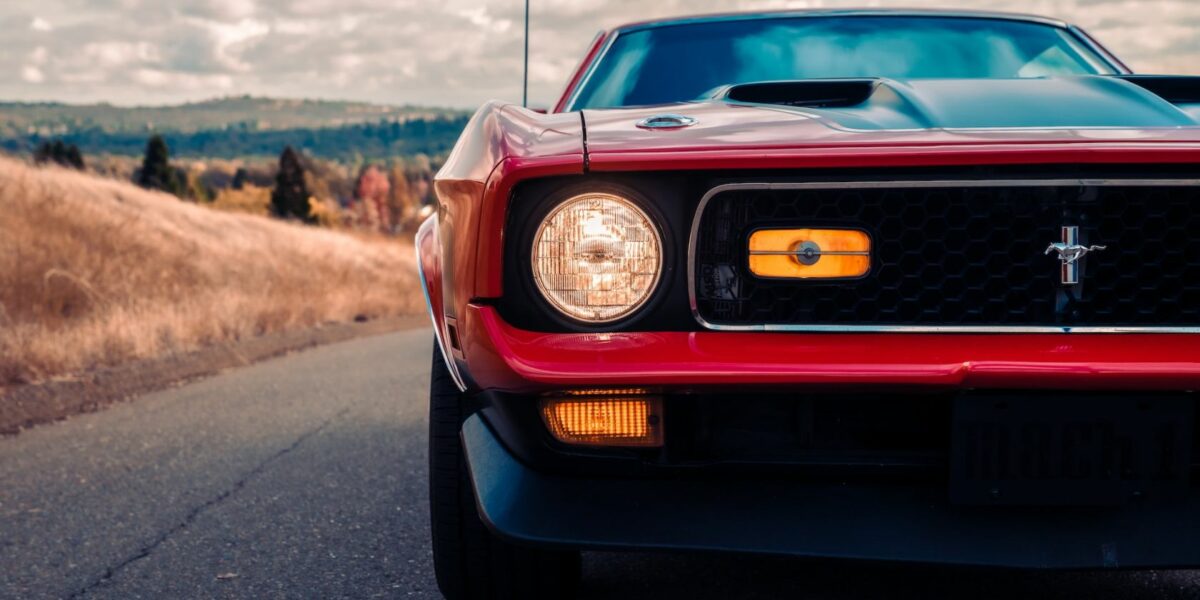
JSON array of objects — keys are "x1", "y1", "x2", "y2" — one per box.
[{"x1": 0, "y1": 96, "x2": 462, "y2": 138}]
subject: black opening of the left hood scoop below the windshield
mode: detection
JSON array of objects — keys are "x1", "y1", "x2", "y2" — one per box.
[{"x1": 713, "y1": 79, "x2": 880, "y2": 108}]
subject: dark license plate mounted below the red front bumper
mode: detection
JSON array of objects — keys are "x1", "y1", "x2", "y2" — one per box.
[{"x1": 950, "y1": 396, "x2": 1194, "y2": 506}]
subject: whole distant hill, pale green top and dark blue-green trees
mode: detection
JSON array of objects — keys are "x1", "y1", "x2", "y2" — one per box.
[{"x1": 0, "y1": 97, "x2": 469, "y2": 160}]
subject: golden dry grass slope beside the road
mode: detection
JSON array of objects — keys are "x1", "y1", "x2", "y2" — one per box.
[{"x1": 0, "y1": 158, "x2": 421, "y2": 388}]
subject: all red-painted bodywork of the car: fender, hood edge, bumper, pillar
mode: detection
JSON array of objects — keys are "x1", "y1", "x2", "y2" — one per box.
[{"x1": 416, "y1": 14, "x2": 1200, "y2": 391}]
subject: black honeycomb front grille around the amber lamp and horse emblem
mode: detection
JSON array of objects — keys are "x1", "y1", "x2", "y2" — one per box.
[{"x1": 691, "y1": 181, "x2": 1200, "y2": 329}]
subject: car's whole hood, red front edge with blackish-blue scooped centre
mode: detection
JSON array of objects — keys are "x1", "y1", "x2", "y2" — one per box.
[{"x1": 583, "y1": 76, "x2": 1200, "y2": 154}]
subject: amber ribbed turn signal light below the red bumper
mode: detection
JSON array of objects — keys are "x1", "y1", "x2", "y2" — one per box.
[{"x1": 541, "y1": 390, "x2": 662, "y2": 448}]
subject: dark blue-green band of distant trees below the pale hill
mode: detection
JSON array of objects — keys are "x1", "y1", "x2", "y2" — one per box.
[{"x1": 8, "y1": 116, "x2": 468, "y2": 161}]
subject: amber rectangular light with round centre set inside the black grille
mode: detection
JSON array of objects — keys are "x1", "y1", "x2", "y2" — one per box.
[{"x1": 750, "y1": 229, "x2": 871, "y2": 280}]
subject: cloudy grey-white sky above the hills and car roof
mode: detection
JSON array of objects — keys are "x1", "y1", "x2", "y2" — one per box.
[{"x1": 0, "y1": 0, "x2": 1200, "y2": 108}]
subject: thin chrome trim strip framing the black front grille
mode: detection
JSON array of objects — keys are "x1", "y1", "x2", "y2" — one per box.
[{"x1": 688, "y1": 179, "x2": 1200, "y2": 334}]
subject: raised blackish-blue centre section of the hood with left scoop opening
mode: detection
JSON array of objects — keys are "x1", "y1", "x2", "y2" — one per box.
[{"x1": 710, "y1": 76, "x2": 1200, "y2": 131}]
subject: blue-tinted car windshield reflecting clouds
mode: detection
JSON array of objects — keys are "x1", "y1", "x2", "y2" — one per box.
[{"x1": 571, "y1": 17, "x2": 1115, "y2": 109}]
